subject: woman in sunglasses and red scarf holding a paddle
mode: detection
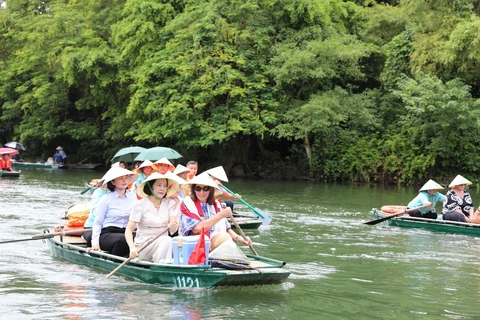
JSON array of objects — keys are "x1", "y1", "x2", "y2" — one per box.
[{"x1": 179, "y1": 172, "x2": 252, "y2": 250}]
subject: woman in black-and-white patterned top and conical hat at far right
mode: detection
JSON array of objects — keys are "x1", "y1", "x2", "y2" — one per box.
[{"x1": 442, "y1": 175, "x2": 473, "y2": 222}]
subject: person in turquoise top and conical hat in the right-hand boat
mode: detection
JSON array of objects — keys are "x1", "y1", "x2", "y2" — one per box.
[{"x1": 407, "y1": 179, "x2": 445, "y2": 219}]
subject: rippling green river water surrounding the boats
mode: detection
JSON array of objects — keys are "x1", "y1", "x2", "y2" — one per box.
[{"x1": 0, "y1": 169, "x2": 480, "y2": 320}]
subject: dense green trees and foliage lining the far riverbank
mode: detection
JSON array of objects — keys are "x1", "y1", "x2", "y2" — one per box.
[{"x1": 0, "y1": 0, "x2": 480, "y2": 183}]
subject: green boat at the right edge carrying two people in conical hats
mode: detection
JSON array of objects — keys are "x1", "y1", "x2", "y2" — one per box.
[{"x1": 371, "y1": 209, "x2": 480, "y2": 236}]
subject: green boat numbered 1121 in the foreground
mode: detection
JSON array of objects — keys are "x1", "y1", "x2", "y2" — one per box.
[{"x1": 46, "y1": 232, "x2": 290, "y2": 288}]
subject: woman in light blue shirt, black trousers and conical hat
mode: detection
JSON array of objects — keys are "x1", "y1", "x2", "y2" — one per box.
[{"x1": 92, "y1": 167, "x2": 138, "y2": 256}]
